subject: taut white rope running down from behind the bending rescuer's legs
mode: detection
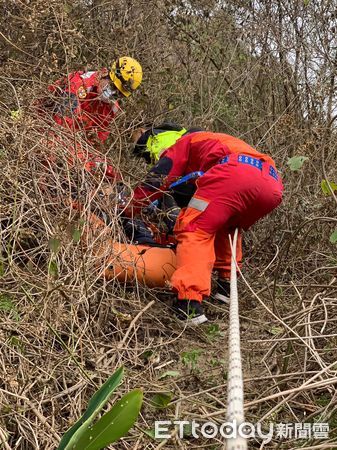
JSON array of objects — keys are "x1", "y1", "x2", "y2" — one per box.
[{"x1": 227, "y1": 229, "x2": 247, "y2": 450}]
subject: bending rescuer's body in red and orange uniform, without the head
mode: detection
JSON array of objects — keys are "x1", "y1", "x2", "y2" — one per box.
[{"x1": 133, "y1": 132, "x2": 283, "y2": 324}]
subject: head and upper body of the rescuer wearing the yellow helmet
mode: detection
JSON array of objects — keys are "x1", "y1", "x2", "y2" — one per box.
[{"x1": 42, "y1": 56, "x2": 143, "y2": 142}]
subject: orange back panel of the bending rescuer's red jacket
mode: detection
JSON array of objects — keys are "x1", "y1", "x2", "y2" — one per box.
[{"x1": 190, "y1": 131, "x2": 275, "y2": 167}]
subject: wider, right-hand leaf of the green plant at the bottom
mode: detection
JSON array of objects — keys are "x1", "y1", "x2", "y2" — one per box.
[{"x1": 73, "y1": 389, "x2": 143, "y2": 450}]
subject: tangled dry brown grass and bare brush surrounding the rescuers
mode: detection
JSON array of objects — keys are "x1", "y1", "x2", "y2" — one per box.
[{"x1": 0, "y1": 0, "x2": 337, "y2": 450}]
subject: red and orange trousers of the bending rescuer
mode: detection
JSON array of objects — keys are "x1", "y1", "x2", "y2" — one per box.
[{"x1": 171, "y1": 155, "x2": 283, "y2": 301}]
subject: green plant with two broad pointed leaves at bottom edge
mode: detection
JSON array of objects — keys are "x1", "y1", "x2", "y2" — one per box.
[{"x1": 57, "y1": 367, "x2": 143, "y2": 450}]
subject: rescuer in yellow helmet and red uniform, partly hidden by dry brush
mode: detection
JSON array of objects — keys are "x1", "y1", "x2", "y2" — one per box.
[{"x1": 38, "y1": 56, "x2": 142, "y2": 180}]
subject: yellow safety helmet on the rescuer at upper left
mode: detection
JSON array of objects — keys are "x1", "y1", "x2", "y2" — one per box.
[{"x1": 109, "y1": 56, "x2": 143, "y2": 97}]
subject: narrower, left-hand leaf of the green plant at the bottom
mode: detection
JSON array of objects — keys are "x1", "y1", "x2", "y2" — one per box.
[{"x1": 57, "y1": 367, "x2": 124, "y2": 450}]
